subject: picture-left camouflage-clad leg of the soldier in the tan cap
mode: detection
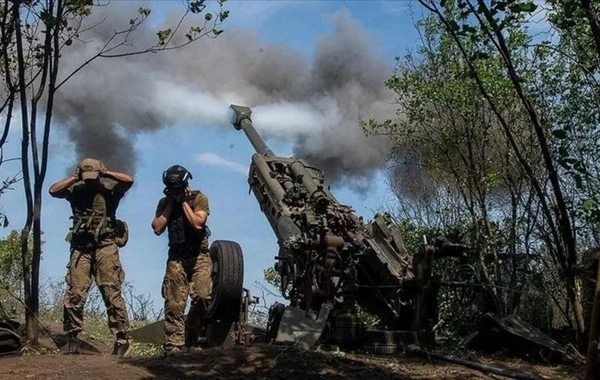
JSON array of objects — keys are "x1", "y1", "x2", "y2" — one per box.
[{"x1": 63, "y1": 249, "x2": 92, "y2": 336}]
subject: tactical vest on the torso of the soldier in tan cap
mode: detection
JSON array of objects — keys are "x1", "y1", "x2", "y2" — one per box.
[{"x1": 67, "y1": 179, "x2": 122, "y2": 247}]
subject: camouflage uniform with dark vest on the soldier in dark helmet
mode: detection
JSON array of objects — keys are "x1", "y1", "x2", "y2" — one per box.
[{"x1": 156, "y1": 192, "x2": 212, "y2": 350}]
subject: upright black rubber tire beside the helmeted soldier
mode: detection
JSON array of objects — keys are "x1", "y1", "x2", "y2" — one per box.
[{"x1": 206, "y1": 240, "x2": 244, "y2": 323}]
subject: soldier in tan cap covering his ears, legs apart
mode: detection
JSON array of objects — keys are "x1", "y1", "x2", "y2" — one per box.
[{"x1": 49, "y1": 158, "x2": 133, "y2": 357}]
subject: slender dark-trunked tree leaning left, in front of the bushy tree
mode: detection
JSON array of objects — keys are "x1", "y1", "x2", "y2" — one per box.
[{"x1": 408, "y1": 0, "x2": 596, "y2": 340}]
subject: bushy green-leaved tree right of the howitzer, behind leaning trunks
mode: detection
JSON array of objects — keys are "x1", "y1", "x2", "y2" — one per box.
[{"x1": 367, "y1": 16, "x2": 541, "y2": 332}]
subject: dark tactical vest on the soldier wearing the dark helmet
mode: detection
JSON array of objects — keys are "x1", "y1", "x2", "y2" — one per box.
[{"x1": 167, "y1": 190, "x2": 208, "y2": 253}]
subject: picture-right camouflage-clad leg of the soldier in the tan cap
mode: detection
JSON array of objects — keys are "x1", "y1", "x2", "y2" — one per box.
[{"x1": 94, "y1": 244, "x2": 129, "y2": 340}]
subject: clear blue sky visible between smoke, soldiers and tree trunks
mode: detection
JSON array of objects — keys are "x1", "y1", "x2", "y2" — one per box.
[{"x1": 0, "y1": 0, "x2": 421, "y2": 310}]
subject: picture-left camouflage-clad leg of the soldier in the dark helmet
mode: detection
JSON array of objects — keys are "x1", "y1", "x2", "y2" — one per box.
[{"x1": 161, "y1": 257, "x2": 188, "y2": 351}]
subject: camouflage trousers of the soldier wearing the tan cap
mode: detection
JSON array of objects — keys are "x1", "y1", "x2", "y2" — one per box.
[{"x1": 63, "y1": 244, "x2": 129, "y2": 339}]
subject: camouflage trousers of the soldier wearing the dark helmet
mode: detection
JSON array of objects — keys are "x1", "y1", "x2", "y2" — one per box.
[{"x1": 162, "y1": 251, "x2": 212, "y2": 349}]
